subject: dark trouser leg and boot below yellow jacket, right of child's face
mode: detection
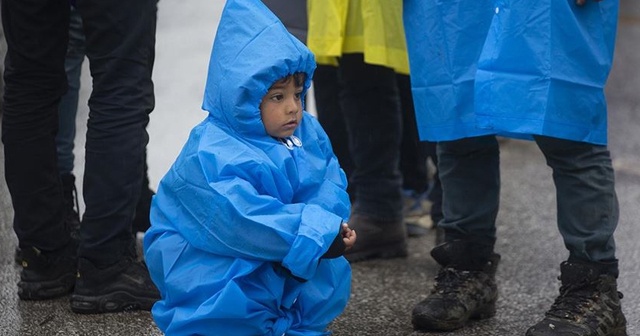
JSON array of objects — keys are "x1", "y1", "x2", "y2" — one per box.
[{"x1": 339, "y1": 54, "x2": 407, "y2": 261}]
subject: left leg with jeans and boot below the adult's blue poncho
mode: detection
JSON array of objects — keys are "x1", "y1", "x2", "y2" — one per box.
[{"x1": 412, "y1": 136, "x2": 500, "y2": 331}]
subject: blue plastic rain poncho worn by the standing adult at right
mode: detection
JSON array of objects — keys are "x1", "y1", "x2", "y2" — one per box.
[{"x1": 404, "y1": 0, "x2": 618, "y2": 144}]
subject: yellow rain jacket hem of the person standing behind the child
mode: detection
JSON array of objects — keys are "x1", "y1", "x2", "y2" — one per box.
[{"x1": 307, "y1": 0, "x2": 409, "y2": 75}]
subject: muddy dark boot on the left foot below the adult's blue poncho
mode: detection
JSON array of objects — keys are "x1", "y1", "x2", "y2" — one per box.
[{"x1": 411, "y1": 240, "x2": 500, "y2": 331}]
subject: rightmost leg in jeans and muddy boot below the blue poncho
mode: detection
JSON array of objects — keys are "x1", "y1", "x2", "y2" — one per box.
[{"x1": 527, "y1": 136, "x2": 626, "y2": 336}]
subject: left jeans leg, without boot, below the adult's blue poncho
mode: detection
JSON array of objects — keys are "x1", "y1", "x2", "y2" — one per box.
[{"x1": 437, "y1": 136, "x2": 500, "y2": 253}]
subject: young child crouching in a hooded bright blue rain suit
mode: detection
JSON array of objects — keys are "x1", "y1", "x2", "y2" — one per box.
[{"x1": 144, "y1": 0, "x2": 356, "y2": 335}]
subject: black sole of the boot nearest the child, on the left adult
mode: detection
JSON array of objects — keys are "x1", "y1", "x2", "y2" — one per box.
[{"x1": 70, "y1": 292, "x2": 158, "y2": 314}]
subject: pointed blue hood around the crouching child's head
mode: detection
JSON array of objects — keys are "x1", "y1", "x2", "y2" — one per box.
[{"x1": 202, "y1": 0, "x2": 316, "y2": 137}]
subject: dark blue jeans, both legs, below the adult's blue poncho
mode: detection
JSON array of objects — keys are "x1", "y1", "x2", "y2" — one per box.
[{"x1": 438, "y1": 136, "x2": 618, "y2": 263}]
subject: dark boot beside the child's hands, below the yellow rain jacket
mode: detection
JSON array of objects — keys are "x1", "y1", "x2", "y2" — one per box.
[{"x1": 344, "y1": 214, "x2": 408, "y2": 262}]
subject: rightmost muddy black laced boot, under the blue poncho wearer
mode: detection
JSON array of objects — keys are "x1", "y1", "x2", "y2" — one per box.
[{"x1": 527, "y1": 262, "x2": 627, "y2": 336}]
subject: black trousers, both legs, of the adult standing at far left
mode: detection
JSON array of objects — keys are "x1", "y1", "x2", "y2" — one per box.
[{"x1": 2, "y1": 0, "x2": 157, "y2": 266}]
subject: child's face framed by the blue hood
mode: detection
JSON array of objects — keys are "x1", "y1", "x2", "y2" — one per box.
[{"x1": 260, "y1": 77, "x2": 302, "y2": 138}]
